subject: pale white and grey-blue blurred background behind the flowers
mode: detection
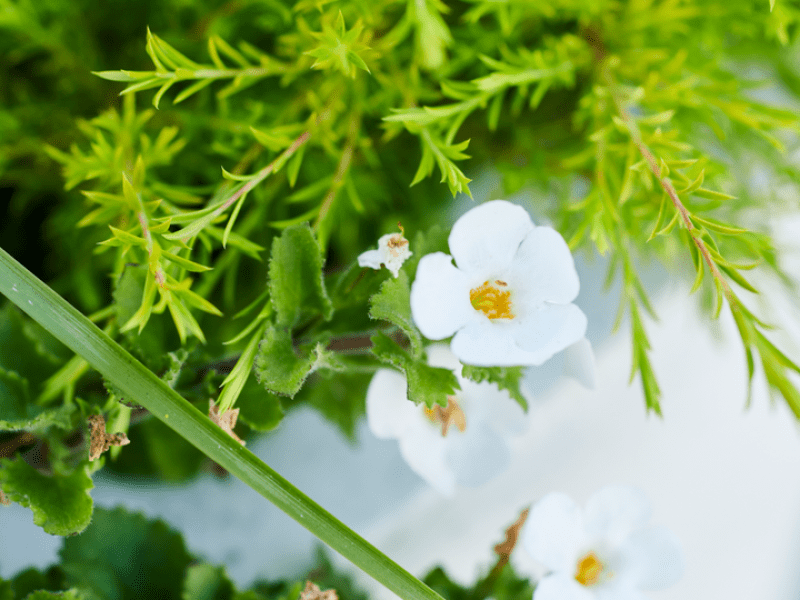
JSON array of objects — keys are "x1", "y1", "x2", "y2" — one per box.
[{"x1": 0, "y1": 191, "x2": 800, "y2": 600}]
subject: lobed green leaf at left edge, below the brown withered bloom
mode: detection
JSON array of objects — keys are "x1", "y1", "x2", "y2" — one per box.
[{"x1": 0, "y1": 458, "x2": 94, "y2": 535}]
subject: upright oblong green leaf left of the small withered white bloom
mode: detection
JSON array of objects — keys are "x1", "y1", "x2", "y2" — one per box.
[{"x1": 269, "y1": 223, "x2": 333, "y2": 328}]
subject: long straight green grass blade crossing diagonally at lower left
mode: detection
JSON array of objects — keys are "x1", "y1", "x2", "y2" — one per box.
[{"x1": 0, "y1": 248, "x2": 442, "y2": 600}]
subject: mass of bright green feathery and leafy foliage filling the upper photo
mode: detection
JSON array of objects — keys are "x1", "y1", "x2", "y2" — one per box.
[{"x1": 0, "y1": 0, "x2": 800, "y2": 584}]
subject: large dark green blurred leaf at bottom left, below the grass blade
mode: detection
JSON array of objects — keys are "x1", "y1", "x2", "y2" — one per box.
[{"x1": 59, "y1": 507, "x2": 192, "y2": 600}]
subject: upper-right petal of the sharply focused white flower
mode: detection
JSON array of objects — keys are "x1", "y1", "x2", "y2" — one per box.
[{"x1": 504, "y1": 227, "x2": 580, "y2": 306}]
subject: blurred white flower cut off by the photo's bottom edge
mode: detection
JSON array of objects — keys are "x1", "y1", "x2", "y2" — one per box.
[{"x1": 522, "y1": 486, "x2": 683, "y2": 600}]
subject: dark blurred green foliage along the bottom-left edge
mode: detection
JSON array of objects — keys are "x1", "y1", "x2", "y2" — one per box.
[{"x1": 0, "y1": 508, "x2": 366, "y2": 600}]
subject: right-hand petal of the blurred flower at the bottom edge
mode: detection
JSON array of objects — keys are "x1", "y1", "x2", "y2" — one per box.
[{"x1": 620, "y1": 527, "x2": 684, "y2": 590}]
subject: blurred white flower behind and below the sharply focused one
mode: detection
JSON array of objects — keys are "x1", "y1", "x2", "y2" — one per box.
[{"x1": 367, "y1": 345, "x2": 526, "y2": 495}]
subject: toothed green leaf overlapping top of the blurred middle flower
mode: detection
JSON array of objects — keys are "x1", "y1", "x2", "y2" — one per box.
[{"x1": 370, "y1": 332, "x2": 461, "y2": 408}]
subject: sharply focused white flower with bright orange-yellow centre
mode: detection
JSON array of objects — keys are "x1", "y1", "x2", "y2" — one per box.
[{"x1": 411, "y1": 200, "x2": 586, "y2": 366}]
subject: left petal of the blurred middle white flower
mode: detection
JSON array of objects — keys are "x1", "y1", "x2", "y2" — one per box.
[{"x1": 367, "y1": 369, "x2": 421, "y2": 438}]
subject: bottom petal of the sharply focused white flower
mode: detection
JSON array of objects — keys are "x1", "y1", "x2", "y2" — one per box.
[{"x1": 450, "y1": 318, "x2": 538, "y2": 367}]
